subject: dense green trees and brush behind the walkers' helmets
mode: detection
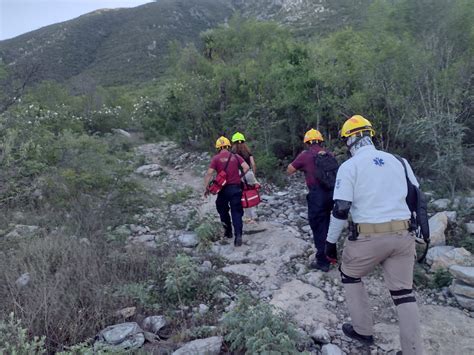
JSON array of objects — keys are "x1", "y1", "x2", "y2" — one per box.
[{"x1": 144, "y1": 0, "x2": 474, "y2": 194}]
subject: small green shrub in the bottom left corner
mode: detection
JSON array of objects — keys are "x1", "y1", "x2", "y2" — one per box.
[{"x1": 0, "y1": 313, "x2": 46, "y2": 355}]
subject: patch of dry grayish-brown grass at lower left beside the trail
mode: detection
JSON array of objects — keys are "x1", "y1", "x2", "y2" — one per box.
[{"x1": 0, "y1": 235, "x2": 172, "y2": 350}]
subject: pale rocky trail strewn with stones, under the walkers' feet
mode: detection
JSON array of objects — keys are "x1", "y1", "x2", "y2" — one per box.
[{"x1": 104, "y1": 142, "x2": 474, "y2": 354}]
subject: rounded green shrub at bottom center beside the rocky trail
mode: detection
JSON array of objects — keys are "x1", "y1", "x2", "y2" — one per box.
[{"x1": 224, "y1": 295, "x2": 300, "y2": 354}]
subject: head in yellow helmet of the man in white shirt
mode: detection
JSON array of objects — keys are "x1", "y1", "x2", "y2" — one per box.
[{"x1": 339, "y1": 115, "x2": 375, "y2": 155}]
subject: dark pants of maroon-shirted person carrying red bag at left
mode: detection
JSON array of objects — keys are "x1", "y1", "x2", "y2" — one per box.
[{"x1": 216, "y1": 185, "x2": 244, "y2": 235}]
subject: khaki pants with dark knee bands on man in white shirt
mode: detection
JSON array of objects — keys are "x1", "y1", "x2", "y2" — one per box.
[{"x1": 341, "y1": 231, "x2": 423, "y2": 355}]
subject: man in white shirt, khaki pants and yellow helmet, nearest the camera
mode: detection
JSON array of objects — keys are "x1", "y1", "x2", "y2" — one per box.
[{"x1": 326, "y1": 115, "x2": 423, "y2": 355}]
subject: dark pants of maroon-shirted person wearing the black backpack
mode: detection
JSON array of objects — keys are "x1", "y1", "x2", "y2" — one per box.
[{"x1": 306, "y1": 186, "x2": 334, "y2": 265}]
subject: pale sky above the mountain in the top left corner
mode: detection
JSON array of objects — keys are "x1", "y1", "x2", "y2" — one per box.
[{"x1": 0, "y1": 0, "x2": 152, "y2": 40}]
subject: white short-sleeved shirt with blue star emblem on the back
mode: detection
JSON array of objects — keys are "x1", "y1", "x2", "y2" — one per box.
[{"x1": 334, "y1": 146, "x2": 418, "y2": 223}]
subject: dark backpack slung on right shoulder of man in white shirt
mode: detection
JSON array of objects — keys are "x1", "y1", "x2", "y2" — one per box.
[{"x1": 394, "y1": 154, "x2": 430, "y2": 262}]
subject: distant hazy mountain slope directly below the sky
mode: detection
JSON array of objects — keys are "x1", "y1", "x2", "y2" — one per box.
[{"x1": 0, "y1": 0, "x2": 372, "y2": 85}]
